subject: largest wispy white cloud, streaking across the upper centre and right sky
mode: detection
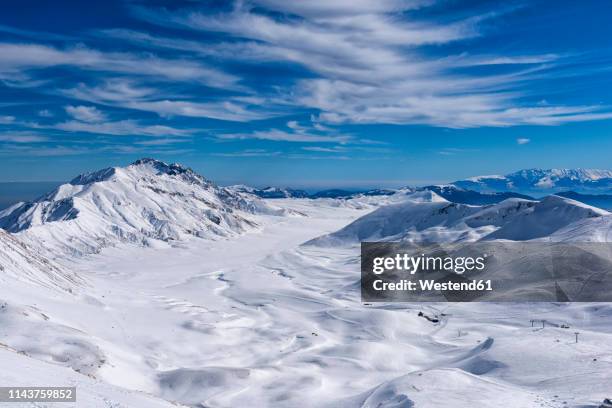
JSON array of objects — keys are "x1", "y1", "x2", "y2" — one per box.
[{"x1": 130, "y1": 0, "x2": 610, "y2": 128}]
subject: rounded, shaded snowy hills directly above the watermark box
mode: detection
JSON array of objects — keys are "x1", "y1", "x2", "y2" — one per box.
[{"x1": 309, "y1": 190, "x2": 610, "y2": 246}]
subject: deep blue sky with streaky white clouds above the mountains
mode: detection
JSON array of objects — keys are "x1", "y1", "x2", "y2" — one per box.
[{"x1": 0, "y1": 0, "x2": 612, "y2": 188}]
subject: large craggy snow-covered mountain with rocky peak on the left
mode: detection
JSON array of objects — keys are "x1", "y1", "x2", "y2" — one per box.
[{"x1": 0, "y1": 159, "x2": 282, "y2": 254}]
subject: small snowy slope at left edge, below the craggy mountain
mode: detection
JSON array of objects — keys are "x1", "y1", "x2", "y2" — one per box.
[{"x1": 0, "y1": 229, "x2": 83, "y2": 291}]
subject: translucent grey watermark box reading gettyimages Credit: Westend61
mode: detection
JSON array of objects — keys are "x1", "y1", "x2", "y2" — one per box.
[{"x1": 361, "y1": 241, "x2": 612, "y2": 302}]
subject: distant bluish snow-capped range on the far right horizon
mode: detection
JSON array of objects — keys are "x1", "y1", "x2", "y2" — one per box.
[{"x1": 452, "y1": 169, "x2": 612, "y2": 194}]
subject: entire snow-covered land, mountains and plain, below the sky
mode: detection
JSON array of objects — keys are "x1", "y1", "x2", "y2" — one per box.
[{"x1": 0, "y1": 159, "x2": 612, "y2": 408}]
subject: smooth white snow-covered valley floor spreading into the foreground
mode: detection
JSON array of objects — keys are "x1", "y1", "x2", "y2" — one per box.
[{"x1": 0, "y1": 199, "x2": 612, "y2": 408}]
